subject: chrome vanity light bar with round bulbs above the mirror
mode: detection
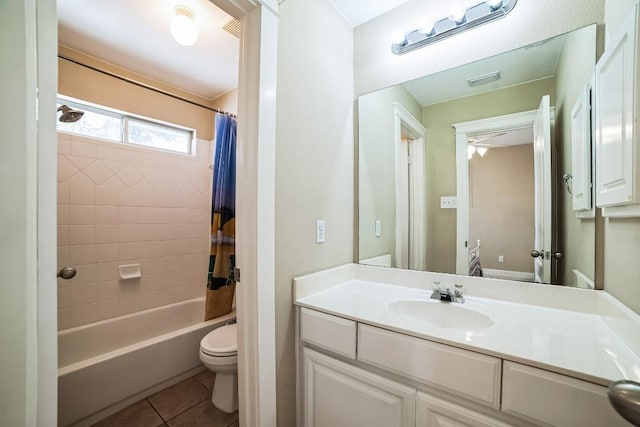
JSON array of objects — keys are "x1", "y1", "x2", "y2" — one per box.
[{"x1": 391, "y1": 0, "x2": 518, "y2": 55}]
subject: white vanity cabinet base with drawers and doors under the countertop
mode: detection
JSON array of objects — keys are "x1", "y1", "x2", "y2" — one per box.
[{"x1": 298, "y1": 308, "x2": 630, "y2": 427}]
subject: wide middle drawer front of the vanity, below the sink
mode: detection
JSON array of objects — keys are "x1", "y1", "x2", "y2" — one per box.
[{"x1": 358, "y1": 324, "x2": 501, "y2": 409}]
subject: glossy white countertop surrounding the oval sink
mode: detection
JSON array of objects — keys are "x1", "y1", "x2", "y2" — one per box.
[{"x1": 295, "y1": 266, "x2": 640, "y2": 386}]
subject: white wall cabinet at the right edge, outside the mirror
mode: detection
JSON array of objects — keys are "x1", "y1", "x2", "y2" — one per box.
[{"x1": 595, "y1": 5, "x2": 640, "y2": 207}]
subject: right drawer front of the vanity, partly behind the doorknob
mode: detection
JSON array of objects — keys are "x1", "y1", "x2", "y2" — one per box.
[{"x1": 502, "y1": 361, "x2": 631, "y2": 427}]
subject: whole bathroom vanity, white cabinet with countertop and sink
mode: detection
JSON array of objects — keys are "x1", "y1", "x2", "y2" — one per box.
[{"x1": 294, "y1": 264, "x2": 640, "y2": 427}]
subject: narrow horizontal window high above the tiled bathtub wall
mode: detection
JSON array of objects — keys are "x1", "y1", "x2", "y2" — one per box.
[{"x1": 57, "y1": 97, "x2": 195, "y2": 154}]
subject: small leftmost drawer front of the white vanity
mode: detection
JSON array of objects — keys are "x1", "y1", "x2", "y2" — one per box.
[{"x1": 300, "y1": 308, "x2": 356, "y2": 359}]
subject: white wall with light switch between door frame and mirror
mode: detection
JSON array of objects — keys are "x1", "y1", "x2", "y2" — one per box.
[{"x1": 275, "y1": 0, "x2": 354, "y2": 427}]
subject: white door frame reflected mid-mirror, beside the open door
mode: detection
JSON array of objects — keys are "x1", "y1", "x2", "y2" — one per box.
[{"x1": 451, "y1": 107, "x2": 555, "y2": 276}]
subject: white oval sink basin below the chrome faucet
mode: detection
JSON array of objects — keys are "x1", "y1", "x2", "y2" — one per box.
[{"x1": 389, "y1": 300, "x2": 493, "y2": 331}]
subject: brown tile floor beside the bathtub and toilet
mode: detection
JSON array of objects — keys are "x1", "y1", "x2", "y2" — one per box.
[{"x1": 94, "y1": 370, "x2": 239, "y2": 427}]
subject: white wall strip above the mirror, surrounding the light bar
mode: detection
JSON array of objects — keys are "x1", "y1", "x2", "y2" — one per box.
[{"x1": 354, "y1": 0, "x2": 604, "y2": 95}]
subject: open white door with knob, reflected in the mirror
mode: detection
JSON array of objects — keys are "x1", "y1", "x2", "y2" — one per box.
[{"x1": 531, "y1": 95, "x2": 552, "y2": 283}]
